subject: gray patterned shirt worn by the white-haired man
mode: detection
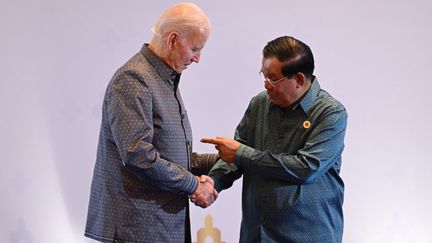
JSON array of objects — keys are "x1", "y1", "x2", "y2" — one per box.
[{"x1": 85, "y1": 45, "x2": 198, "y2": 242}]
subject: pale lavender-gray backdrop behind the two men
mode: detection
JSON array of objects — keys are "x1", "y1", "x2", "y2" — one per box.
[{"x1": 0, "y1": 0, "x2": 432, "y2": 243}]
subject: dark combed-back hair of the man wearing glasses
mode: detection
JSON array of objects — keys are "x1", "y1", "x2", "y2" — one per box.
[{"x1": 263, "y1": 36, "x2": 315, "y2": 78}]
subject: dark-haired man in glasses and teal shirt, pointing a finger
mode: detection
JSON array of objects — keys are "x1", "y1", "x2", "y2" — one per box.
[{"x1": 201, "y1": 36, "x2": 347, "y2": 243}]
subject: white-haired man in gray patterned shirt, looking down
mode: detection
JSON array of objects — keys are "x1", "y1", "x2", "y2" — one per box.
[{"x1": 85, "y1": 3, "x2": 218, "y2": 242}]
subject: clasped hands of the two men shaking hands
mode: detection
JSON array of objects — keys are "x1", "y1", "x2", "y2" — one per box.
[{"x1": 189, "y1": 175, "x2": 219, "y2": 208}]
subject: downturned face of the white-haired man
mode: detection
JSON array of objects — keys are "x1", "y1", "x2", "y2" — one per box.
[{"x1": 167, "y1": 29, "x2": 209, "y2": 73}]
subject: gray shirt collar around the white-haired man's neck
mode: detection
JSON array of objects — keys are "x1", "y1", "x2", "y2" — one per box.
[{"x1": 140, "y1": 43, "x2": 180, "y2": 87}]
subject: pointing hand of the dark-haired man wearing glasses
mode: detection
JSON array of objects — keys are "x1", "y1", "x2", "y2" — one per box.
[{"x1": 201, "y1": 137, "x2": 240, "y2": 163}]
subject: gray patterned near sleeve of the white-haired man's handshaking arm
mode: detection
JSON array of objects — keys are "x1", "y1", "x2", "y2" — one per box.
[{"x1": 106, "y1": 71, "x2": 197, "y2": 194}]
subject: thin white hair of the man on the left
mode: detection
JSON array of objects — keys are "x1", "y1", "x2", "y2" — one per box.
[{"x1": 152, "y1": 3, "x2": 210, "y2": 37}]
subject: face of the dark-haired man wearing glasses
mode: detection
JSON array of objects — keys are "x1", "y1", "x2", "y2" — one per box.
[{"x1": 261, "y1": 57, "x2": 301, "y2": 108}]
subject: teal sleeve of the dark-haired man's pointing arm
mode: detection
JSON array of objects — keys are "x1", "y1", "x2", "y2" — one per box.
[{"x1": 236, "y1": 106, "x2": 347, "y2": 184}]
